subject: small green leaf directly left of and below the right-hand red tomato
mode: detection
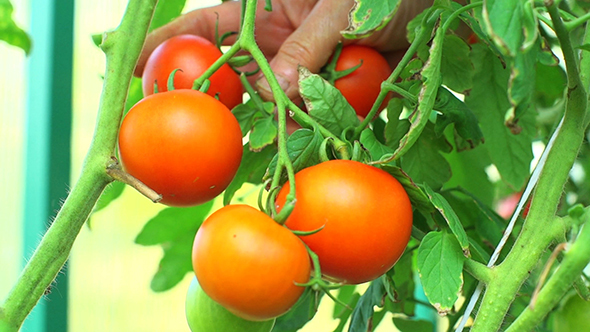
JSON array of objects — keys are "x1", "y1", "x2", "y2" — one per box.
[{"x1": 299, "y1": 67, "x2": 360, "y2": 136}]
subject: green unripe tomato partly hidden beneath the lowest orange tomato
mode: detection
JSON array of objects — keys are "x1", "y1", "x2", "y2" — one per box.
[{"x1": 186, "y1": 278, "x2": 275, "y2": 332}]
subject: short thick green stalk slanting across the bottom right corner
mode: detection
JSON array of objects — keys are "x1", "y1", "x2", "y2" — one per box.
[{"x1": 506, "y1": 213, "x2": 590, "y2": 332}]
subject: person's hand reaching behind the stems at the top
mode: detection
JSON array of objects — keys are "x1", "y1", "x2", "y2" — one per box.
[{"x1": 135, "y1": 0, "x2": 432, "y2": 100}]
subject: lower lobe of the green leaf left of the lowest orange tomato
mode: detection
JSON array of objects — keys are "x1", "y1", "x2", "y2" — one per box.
[{"x1": 150, "y1": 234, "x2": 195, "y2": 292}]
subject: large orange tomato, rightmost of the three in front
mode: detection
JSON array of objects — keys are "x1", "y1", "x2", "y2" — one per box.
[{"x1": 276, "y1": 160, "x2": 412, "y2": 284}]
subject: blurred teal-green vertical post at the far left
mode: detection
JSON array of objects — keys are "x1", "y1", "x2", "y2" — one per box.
[{"x1": 22, "y1": 0, "x2": 74, "y2": 332}]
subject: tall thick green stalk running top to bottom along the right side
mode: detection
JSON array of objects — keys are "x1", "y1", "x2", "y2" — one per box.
[{"x1": 471, "y1": 2, "x2": 590, "y2": 332}]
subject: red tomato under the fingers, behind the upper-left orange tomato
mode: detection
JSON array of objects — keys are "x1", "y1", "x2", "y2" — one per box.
[{"x1": 142, "y1": 35, "x2": 243, "y2": 109}]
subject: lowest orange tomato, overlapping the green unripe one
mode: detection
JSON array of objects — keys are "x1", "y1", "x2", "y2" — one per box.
[{"x1": 193, "y1": 205, "x2": 311, "y2": 320}]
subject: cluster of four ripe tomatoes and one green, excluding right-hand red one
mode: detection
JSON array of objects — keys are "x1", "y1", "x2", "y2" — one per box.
[{"x1": 119, "y1": 36, "x2": 412, "y2": 332}]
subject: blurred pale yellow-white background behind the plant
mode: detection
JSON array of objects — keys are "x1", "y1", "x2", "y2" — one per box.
[{"x1": 0, "y1": 0, "x2": 414, "y2": 332}]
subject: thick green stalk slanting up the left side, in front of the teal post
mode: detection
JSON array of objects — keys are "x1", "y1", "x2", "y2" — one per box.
[{"x1": 0, "y1": 0, "x2": 157, "y2": 332}]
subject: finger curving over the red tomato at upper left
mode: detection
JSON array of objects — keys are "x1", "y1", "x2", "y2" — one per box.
[{"x1": 135, "y1": 1, "x2": 241, "y2": 76}]
